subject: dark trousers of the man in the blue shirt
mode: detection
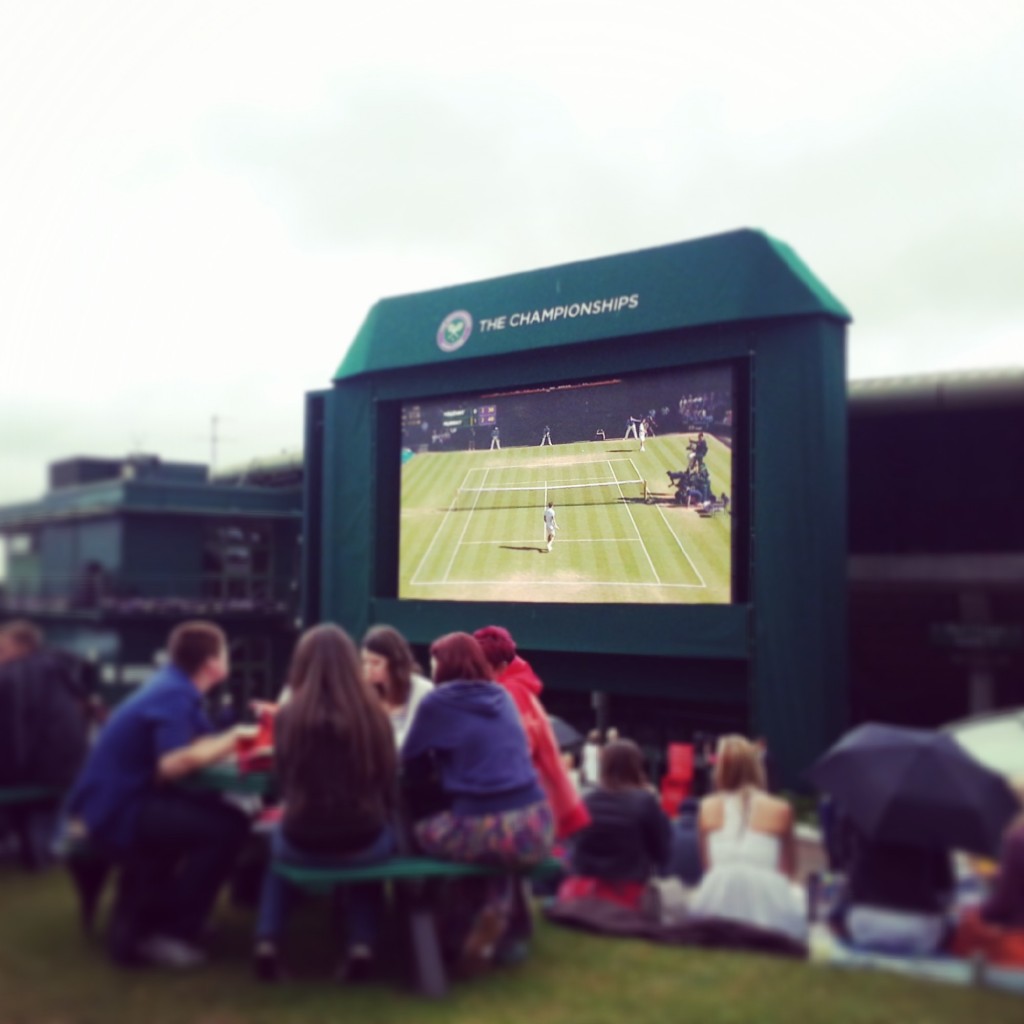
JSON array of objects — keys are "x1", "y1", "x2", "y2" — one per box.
[{"x1": 111, "y1": 790, "x2": 249, "y2": 961}]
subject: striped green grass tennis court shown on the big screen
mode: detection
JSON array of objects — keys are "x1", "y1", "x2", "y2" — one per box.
[{"x1": 398, "y1": 434, "x2": 732, "y2": 604}]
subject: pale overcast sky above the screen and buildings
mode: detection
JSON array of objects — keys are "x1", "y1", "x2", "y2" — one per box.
[{"x1": 0, "y1": 0, "x2": 1024, "y2": 504}]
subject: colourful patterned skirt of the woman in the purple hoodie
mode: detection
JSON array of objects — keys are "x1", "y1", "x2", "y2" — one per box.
[{"x1": 414, "y1": 800, "x2": 555, "y2": 869}]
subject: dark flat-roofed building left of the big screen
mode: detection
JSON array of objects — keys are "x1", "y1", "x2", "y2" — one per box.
[{"x1": 0, "y1": 456, "x2": 301, "y2": 709}]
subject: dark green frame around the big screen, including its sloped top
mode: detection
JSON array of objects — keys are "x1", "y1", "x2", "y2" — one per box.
[{"x1": 306, "y1": 230, "x2": 849, "y2": 785}]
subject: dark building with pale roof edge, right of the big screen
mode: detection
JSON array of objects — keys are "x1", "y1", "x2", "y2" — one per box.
[{"x1": 848, "y1": 370, "x2": 1024, "y2": 725}]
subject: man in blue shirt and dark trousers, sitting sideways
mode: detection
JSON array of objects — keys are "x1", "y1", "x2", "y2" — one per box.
[{"x1": 68, "y1": 622, "x2": 249, "y2": 967}]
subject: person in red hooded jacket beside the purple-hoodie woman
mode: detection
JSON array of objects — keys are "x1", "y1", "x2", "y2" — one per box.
[{"x1": 473, "y1": 626, "x2": 590, "y2": 840}]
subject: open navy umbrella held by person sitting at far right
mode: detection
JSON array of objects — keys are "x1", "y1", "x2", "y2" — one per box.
[{"x1": 808, "y1": 723, "x2": 1020, "y2": 857}]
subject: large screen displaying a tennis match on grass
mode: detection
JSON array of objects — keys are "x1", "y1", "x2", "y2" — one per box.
[{"x1": 398, "y1": 366, "x2": 734, "y2": 604}]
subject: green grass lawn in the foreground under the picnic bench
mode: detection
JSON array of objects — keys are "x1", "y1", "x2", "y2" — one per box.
[{"x1": 0, "y1": 866, "x2": 1024, "y2": 1024}]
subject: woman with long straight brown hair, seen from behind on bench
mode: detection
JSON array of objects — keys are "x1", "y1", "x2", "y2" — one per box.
[{"x1": 255, "y1": 625, "x2": 397, "y2": 981}]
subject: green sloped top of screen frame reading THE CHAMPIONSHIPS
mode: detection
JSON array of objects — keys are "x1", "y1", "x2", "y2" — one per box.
[{"x1": 335, "y1": 228, "x2": 851, "y2": 380}]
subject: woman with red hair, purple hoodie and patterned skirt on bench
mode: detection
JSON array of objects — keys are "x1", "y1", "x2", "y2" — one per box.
[{"x1": 401, "y1": 633, "x2": 555, "y2": 972}]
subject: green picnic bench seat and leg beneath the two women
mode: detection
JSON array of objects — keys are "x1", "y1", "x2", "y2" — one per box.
[{"x1": 271, "y1": 856, "x2": 563, "y2": 997}]
